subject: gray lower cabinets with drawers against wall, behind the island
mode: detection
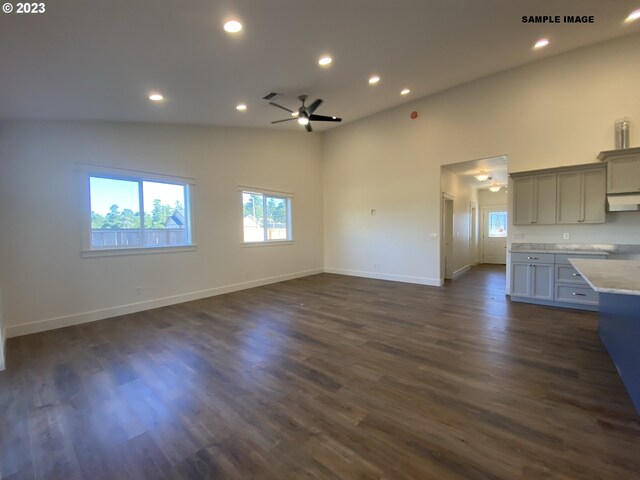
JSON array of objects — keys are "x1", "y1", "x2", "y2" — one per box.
[{"x1": 511, "y1": 252, "x2": 606, "y2": 310}]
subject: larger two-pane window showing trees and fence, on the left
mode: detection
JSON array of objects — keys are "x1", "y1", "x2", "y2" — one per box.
[{"x1": 88, "y1": 172, "x2": 192, "y2": 250}]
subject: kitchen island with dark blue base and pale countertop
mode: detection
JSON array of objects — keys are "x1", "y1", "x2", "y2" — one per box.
[{"x1": 569, "y1": 258, "x2": 640, "y2": 413}]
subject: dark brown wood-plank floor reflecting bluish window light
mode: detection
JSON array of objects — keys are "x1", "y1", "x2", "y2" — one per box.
[{"x1": 0, "y1": 266, "x2": 640, "y2": 480}]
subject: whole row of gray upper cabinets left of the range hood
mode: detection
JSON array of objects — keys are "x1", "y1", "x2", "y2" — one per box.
[{"x1": 511, "y1": 164, "x2": 607, "y2": 225}]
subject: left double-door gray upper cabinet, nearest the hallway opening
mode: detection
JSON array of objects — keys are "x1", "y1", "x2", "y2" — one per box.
[{"x1": 513, "y1": 173, "x2": 556, "y2": 225}]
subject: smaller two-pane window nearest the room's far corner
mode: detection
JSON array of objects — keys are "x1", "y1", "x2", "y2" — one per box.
[{"x1": 242, "y1": 190, "x2": 291, "y2": 243}]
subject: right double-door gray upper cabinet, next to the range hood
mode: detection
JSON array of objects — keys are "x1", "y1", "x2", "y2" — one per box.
[{"x1": 556, "y1": 166, "x2": 606, "y2": 224}]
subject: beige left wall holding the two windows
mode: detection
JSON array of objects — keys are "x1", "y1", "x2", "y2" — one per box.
[{"x1": 0, "y1": 122, "x2": 323, "y2": 337}]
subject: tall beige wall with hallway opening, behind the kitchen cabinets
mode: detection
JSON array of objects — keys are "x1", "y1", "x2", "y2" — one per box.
[{"x1": 322, "y1": 35, "x2": 640, "y2": 284}]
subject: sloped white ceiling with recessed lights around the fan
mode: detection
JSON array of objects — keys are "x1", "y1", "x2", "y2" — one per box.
[{"x1": 0, "y1": 0, "x2": 640, "y2": 130}]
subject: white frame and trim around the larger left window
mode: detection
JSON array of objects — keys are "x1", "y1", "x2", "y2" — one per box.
[{"x1": 78, "y1": 164, "x2": 197, "y2": 257}]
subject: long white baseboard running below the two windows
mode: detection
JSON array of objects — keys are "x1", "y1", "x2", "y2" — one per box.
[{"x1": 6, "y1": 268, "x2": 324, "y2": 338}]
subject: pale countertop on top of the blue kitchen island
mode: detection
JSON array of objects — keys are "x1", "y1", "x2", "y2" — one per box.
[{"x1": 569, "y1": 258, "x2": 640, "y2": 295}]
